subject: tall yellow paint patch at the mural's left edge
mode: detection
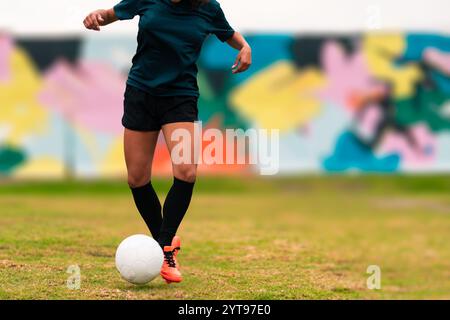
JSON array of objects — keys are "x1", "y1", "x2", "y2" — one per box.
[{"x1": 0, "y1": 49, "x2": 48, "y2": 145}]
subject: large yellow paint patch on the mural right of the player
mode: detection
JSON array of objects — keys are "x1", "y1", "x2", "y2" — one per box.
[{"x1": 230, "y1": 61, "x2": 325, "y2": 130}]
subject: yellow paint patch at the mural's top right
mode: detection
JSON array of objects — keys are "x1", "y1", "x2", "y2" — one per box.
[{"x1": 363, "y1": 34, "x2": 422, "y2": 98}]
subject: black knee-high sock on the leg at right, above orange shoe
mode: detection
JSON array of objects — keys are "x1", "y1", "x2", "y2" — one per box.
[{"x1": 158, "y1": 178, "x2": 194, "y2": 248}]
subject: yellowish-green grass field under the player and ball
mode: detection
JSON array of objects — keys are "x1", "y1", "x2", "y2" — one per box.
[{"x1": 0, "y1": 176, "x2": 450, "y2": 299}]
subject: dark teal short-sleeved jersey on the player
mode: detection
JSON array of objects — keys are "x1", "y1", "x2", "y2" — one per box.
[{"x1": 114, "y1": 0, "x2": 234, "y2": 96}]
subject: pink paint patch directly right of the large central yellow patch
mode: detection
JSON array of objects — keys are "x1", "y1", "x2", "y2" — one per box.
[{"x1": 319, "y1": 41, "x2": 374, "y2": 111}]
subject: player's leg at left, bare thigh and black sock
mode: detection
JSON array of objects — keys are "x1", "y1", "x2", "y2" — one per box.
[{"x1": 124, "y1": 129, "x2": 162, "y2": 239}]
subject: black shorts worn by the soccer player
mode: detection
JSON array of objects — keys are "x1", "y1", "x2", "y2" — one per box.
[{"x1": 122, "y1": 85, "x2": 198, "y2": 131}]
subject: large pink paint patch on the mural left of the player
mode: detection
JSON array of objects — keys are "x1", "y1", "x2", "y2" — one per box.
[{"x1": 39, "y1": 60, "x2": 125, "y2": 133}]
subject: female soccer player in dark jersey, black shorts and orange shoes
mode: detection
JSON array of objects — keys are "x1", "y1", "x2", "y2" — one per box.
[{"x1": 84, "y1": 0, "x2": 252, "y2": 283}]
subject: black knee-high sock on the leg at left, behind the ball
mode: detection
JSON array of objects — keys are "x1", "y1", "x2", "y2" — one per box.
[{"x1": 131, "y1": 182, "x2": 162, "y2": 240}]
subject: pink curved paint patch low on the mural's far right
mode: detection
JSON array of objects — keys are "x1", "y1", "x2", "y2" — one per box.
[{"x1": 380, "y1": 124, "x2": 437, "y2": 168}]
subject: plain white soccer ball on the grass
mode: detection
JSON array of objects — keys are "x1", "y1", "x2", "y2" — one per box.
[{"x1": 116, "y1": 234, "x2": 164, "y2": 284}]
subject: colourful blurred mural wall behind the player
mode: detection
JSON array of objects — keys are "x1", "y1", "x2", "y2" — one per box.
[{"x1": 0, "y1": 33, "x2": 450, "y2": 178}]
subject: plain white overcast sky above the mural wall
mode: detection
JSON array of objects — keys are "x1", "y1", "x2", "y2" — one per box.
[{"x1": 0, "y1": 0, "x2": 450, "y2": 34}]
